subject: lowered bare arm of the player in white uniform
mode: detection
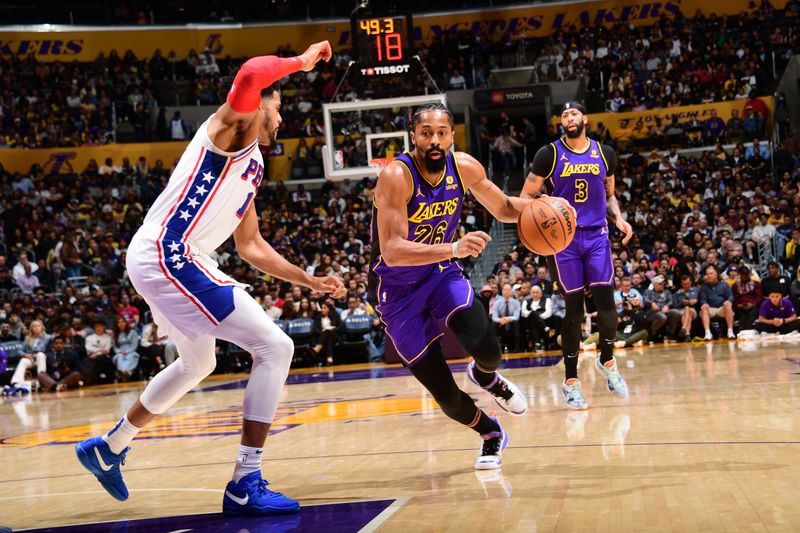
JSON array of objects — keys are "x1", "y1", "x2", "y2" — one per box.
[{"x1": 233, "y1": 204, "x2": 347, "y2": 298}]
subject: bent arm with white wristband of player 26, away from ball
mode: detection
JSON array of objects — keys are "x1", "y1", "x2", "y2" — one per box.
[{"x1": 375, "y1": 160, "x2": 491, "y2": 266}]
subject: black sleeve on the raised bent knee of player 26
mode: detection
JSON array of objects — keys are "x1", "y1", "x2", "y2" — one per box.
[{"x1": 450, "y1": 300, "x2": 502, "y2": 371}]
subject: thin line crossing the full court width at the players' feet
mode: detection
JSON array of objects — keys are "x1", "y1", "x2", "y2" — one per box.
[{"x1": 0, "y1": 440, "x2": 800, "y2": 485}]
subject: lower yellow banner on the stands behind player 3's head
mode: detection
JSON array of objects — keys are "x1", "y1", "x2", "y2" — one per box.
[{"x1": 551, "y1": 96, "x2": 775, "y2": 140}]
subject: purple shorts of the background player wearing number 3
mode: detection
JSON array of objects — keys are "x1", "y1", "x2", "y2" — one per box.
[{"x1": 554, "y1": 222, "x2": 614, "y2": 294}]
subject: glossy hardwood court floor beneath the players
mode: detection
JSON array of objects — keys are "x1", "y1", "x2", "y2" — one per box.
[{"x1": 0, "y1": 342, "x2": 800, "y2": 533}]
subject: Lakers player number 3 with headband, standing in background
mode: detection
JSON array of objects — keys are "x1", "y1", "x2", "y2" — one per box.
[{"x1": 520, "y1": 102, "x2": 633, "y2": 409}]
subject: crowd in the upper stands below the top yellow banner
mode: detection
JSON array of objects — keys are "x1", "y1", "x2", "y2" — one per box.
[{"x1": 0, "y1": 0, "x2": 800, "y2": 148}]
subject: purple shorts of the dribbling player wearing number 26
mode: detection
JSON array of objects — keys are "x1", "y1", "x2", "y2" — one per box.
[{"x1": 375, "y1": 262, "x2": 475, "y2": 365}]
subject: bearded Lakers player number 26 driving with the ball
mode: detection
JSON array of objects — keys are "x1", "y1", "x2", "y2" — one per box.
[{"x1": 370, "y1": 104, "x2": 528, "y2": 470}]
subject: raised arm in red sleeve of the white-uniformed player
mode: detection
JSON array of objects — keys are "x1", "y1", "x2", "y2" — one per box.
[{"x1": 208, "y1": 41, "x2": 332, "y2": 151}]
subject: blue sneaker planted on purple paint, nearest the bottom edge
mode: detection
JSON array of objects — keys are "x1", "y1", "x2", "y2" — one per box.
[{"x1": 222, "y1": 471, "x2": 300, "y2": 516}]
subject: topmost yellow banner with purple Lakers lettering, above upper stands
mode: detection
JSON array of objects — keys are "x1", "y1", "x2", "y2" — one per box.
[{"x1": 0, "y1": 0, "x2": 787, "y2": 61}]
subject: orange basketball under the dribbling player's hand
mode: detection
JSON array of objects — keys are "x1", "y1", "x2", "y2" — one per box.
[{"x1": 517, "y1": 196, "x2": 576, "y2": 255}]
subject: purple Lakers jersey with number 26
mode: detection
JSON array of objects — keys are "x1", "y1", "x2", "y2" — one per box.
[{"x1": 370, "y1": 152, "x2": 465, "y2": 285}]
